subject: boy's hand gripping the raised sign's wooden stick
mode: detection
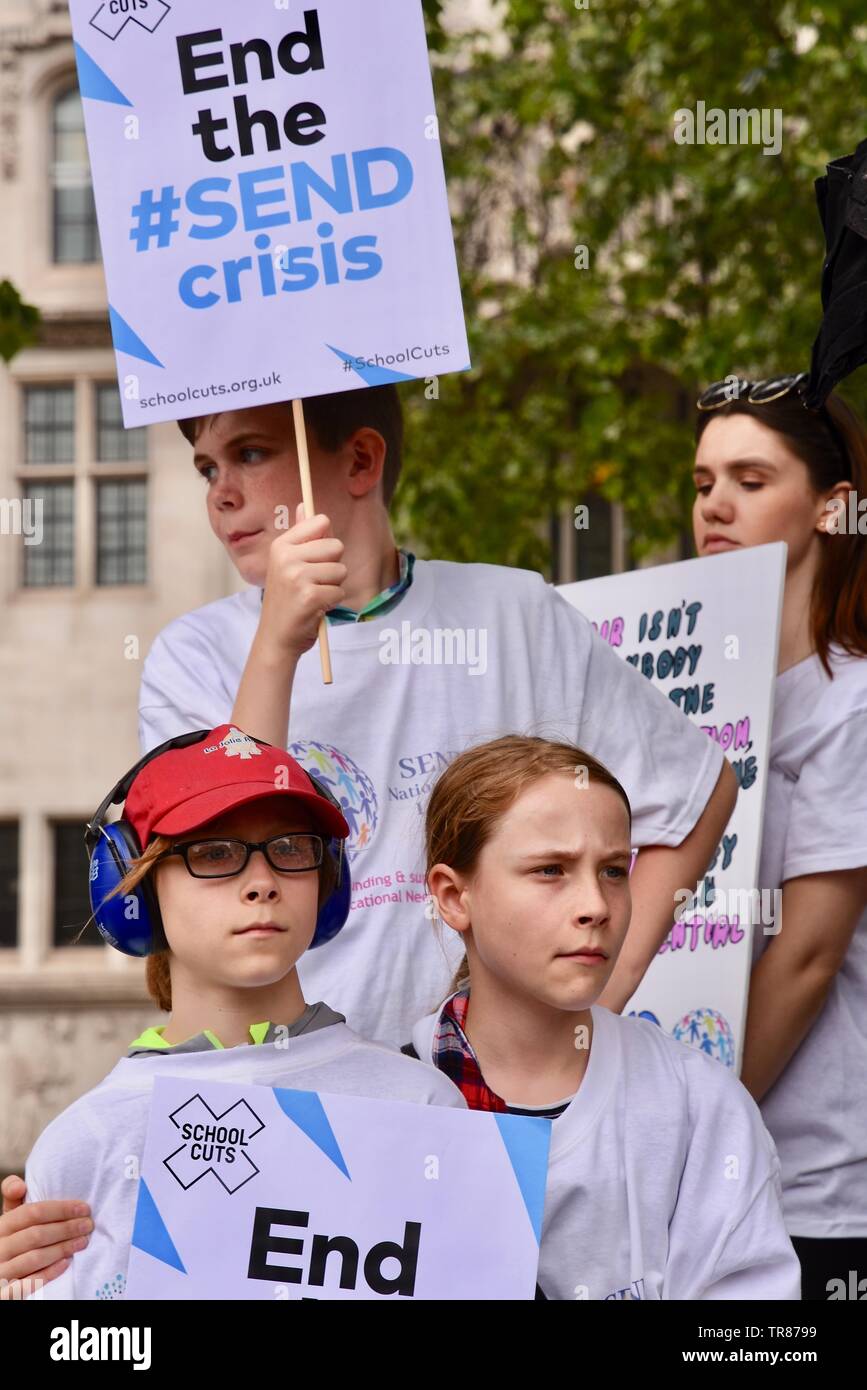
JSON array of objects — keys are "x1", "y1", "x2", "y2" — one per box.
[{"x1": 258, "y1": 503, "x2": 347, "y2": 657}]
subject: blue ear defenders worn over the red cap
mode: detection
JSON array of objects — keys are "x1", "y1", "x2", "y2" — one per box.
[{"x1": 85, "y1": 728, "x2": 352, "y2": 956}]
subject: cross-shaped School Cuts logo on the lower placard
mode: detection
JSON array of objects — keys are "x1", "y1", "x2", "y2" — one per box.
[{"x1": 163, "y1": 1094, "x2": 265, "y2": 1194}]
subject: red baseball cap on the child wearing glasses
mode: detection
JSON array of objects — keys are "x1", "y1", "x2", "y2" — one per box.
[{"x1": 124, "y1": 724, "x2": 349, "y2": 849}]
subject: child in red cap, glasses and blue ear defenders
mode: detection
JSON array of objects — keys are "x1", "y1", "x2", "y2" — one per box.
[{"x1": 16, "y1": 726, "x2": 464, "y2": 1300}]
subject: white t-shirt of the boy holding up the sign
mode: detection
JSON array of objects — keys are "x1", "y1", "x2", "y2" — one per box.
[{"x1": 139, "y1": 560, "x2": 723, "y2": 1045}]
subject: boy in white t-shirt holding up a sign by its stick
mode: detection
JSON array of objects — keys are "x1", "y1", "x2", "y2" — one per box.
[{"x1": 140, "y1": 386, "x2": 735, "y2": 1044}]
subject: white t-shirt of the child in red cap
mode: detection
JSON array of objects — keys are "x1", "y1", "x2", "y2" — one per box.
[{"x1": 25, "y1": 1023, "x2": 465, "y2": 1300}]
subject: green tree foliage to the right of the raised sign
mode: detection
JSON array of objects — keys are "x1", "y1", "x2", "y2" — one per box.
[{"x1": 399, "y1": 0, "x2": 867, "y2": 569}]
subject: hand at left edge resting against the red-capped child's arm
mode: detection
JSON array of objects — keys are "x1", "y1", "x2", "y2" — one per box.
[{"x1": 0, "y1": 1175, "x2": 93, "y2": 1302}]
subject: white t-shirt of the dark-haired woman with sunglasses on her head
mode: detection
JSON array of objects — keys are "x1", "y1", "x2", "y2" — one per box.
[{"x1": 753, "y1": 649, "x2": 867, "y2": 1238}]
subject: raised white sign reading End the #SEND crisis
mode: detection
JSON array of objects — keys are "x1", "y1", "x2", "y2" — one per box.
[{"x1": 71, "y1": 0, "x2": 470, "y2": 428}]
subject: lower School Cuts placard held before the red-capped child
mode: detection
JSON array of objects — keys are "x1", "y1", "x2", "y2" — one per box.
[{"x1": 126, "y1": 1077, "x2": 550, "y2": 1301}]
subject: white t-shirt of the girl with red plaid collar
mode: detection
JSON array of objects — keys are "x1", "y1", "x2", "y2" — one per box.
[{"x1": 413, "y1": 1008, "x2": 800, "y2": 1301}]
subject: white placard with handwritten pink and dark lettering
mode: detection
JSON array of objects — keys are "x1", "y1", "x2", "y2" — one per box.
[{"x1": 560, "y1": 545, "x2": 786, "y2": 1070}]
